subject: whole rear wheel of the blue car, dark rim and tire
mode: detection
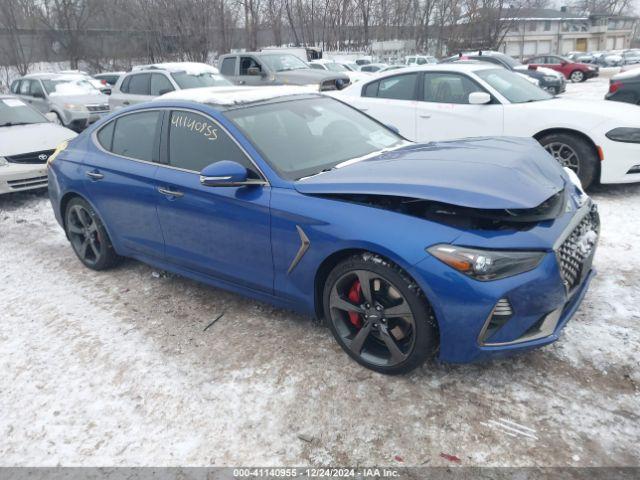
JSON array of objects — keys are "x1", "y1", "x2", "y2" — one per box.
[{"x1": 64, "y1": 197, "x2": 121, "y2": 270}]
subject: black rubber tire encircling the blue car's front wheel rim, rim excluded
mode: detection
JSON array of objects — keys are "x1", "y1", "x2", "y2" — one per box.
[{"x1": 323, "y1": 252, "x2": 439, "y2": 375}]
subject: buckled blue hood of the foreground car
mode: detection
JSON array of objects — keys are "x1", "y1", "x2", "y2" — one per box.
[{"x1": 294, "y1": 137, "x2": 568, "y2": 209}]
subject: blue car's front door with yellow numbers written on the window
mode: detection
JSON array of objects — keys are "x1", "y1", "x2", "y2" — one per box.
[{"x1": 156, "y1": 110, "x2": 273, "y2": 293}]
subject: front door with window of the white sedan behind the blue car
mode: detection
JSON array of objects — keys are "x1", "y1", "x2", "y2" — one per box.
[{"x1": 416, "y1": 72, "x2": 504, "y2": 142}]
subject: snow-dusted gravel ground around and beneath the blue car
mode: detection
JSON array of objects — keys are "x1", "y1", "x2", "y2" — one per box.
[{"x1": 0, "y1": 79, "x2": 640, "y2": 466}]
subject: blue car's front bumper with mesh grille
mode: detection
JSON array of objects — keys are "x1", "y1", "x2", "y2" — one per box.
[{"x1": 414, "y1": 200, "x2": 599, "y2": 363}]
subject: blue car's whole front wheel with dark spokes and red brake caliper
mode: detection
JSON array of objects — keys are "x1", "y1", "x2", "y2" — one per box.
[{"x1": 323, "y1": 253, "x2": 438, "y2": 375}]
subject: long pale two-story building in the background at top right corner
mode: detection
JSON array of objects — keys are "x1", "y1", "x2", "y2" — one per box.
[{"x1": 500, "y1": 7, "x2": 638, "y2": 58}]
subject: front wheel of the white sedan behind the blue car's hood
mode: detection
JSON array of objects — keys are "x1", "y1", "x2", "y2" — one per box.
[{"x1": 538, "y1": 133, "x2": 598, "y2": 189}]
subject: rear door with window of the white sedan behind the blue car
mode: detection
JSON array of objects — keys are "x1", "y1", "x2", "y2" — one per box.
[{"x1": 350, "y1": 72, "x2": 419, "y2": 140}]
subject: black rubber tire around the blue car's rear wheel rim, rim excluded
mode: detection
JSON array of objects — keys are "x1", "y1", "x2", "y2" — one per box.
[{"x1": 65, "y1": 197, "x2": 122, "y2": 270}]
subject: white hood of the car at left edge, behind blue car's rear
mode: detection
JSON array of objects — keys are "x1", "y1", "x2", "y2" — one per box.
[{"x1": 0, "y1": 123, "x2": 77, "y2": 157}]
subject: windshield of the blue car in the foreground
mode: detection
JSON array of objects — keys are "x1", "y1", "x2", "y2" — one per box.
[{"x1": 225, "y1": 97, "x2": 408, "y2": 180}]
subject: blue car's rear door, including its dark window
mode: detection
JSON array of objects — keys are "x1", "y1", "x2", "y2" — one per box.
[{"x1": 81, "y1": 110, "x2": 164, "y2": 258}]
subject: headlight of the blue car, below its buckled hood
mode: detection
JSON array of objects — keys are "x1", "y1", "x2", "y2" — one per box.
[{"x1": 427, "y1": 244, "x2": 545, "y2": 281}]
